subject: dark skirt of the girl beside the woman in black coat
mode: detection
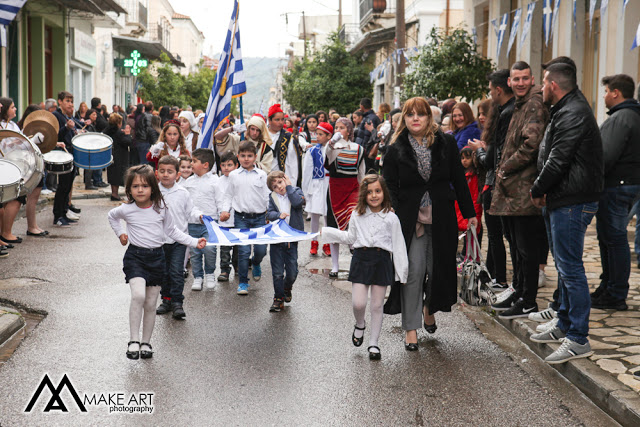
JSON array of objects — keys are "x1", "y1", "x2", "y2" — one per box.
[{"x1": 349, "y1": 248, "x2": 394, "y2": 286}]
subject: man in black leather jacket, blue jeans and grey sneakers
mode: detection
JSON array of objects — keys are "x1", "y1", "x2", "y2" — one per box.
[{"x1": 530, "y1": 64, "x2": 604, "y2": 364}]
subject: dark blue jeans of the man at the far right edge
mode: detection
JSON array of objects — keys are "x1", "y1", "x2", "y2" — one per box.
[{"x1": 596, "y1": 185, "x2": 640, "y2": 300}]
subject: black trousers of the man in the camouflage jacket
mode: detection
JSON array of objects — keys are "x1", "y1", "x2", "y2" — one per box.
[{"x1": 502, "y1": 215, "x2": 540, "y2": 306}]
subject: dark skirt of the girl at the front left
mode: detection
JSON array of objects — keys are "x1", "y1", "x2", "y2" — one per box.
[{"x1": 122, "y1": 244, "x2": 165, "y2": 286}]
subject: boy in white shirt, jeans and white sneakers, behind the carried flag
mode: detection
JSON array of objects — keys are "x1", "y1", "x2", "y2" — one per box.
[{"x1": 183, "y1": 148, "x2": 222, "y2": 291}]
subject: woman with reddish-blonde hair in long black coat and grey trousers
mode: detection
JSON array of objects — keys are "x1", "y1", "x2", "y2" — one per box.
[{"x1": 383, "y1": 97, "x2": 477, "y2": 351}]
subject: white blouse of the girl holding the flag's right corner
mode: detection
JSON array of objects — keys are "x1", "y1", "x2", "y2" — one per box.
[{"x1": 322, "y1": 207, "x2": 409, "y2": 283}]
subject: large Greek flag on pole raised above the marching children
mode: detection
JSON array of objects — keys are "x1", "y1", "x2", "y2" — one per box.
[{"x1": 198, "y1": 0, "x2": 247, "y2": 148}]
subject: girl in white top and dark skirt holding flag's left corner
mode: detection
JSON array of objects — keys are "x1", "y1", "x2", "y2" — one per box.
[{"x1": 108, "y1": 165, "x2": 207, "y2": 359}]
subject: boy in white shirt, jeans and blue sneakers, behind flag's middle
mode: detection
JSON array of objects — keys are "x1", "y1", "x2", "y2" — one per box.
[{"x1": 221, "y1": 141, "x2": 270, "y2": 295}]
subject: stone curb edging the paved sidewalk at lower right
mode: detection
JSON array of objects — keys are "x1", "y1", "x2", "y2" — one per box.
[{"x1": 484, "y1": 312, "x2": 640, "y2": 426}]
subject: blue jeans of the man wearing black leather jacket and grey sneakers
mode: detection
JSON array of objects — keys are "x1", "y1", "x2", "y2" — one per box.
[{"x1": 549, "y1": 202, "x2": 598, "y2": 344}]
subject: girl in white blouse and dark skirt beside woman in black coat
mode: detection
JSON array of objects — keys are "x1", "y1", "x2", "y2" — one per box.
[{"x1": 322, "y1": 174, "x2": 409, "y2": 360}]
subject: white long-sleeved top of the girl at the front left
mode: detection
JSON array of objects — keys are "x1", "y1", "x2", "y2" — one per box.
[{"x1": 107, "y1": 203, "x2": 198, "y2": 249}]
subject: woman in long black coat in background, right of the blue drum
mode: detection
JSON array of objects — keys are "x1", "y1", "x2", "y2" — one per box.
[{"x1": 103, "y1": 113, "x2": 133, "y2": 201}]
